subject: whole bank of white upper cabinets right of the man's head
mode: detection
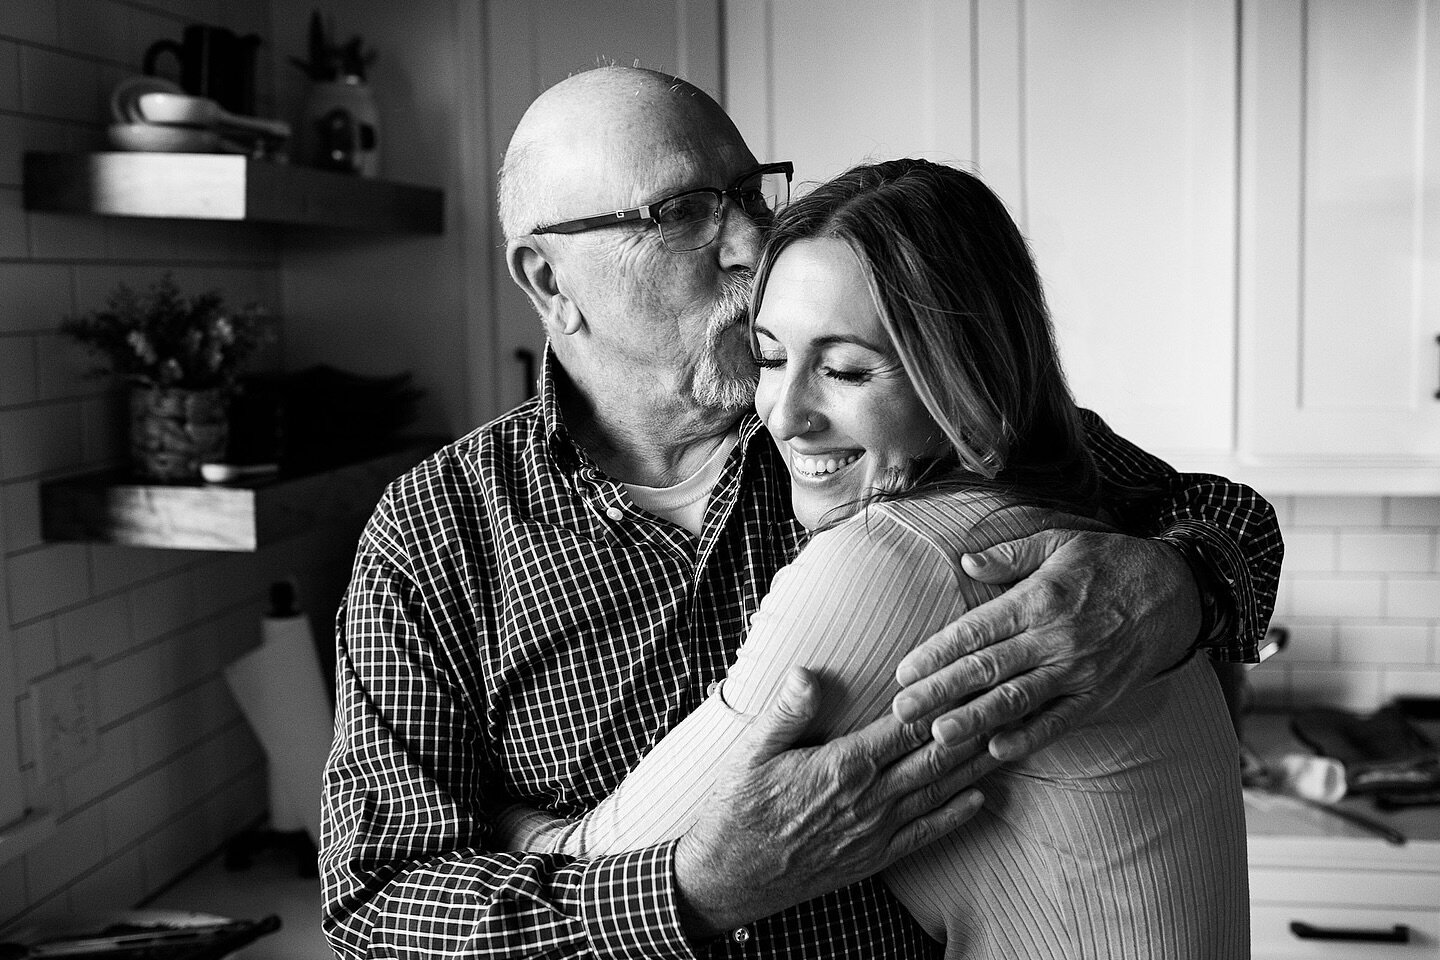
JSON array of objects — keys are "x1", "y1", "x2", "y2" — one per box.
[{"x1": 724, "y1": 0, "x2": 1440, "y2": 494}]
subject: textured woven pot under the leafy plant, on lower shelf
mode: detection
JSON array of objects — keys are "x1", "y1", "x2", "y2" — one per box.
[{"x1": 130, "y1": 387, "x2": 230, "y2": 484}]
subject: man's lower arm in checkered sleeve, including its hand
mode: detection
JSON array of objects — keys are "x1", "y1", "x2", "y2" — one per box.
[{"x1": 321, "y1": 503, "x2": 972, "y2": 960}]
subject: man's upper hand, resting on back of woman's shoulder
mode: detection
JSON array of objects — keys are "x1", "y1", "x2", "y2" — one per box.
[{"x1": 894, "y1": 518, "x2": 1200, "y2": 760}]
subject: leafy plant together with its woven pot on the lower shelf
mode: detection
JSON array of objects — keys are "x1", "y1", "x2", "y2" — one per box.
[{"x1": 60, "y1": 273, "x2": 271, "y2": 482}]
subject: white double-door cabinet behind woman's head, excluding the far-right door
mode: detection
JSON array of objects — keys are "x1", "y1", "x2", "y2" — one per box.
[{"x1": 726, "y1": 0, "x2": 1237, "y2": 466}]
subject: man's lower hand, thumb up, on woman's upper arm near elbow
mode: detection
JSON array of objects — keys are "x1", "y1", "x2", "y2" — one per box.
[{"x1": 675, "y1": 669, "x2": 998, "y2": 938}]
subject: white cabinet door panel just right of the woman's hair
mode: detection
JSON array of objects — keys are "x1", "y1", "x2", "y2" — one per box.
[{"x1": 1025, "y1": 0, "x2": 1237, "y2": 466}]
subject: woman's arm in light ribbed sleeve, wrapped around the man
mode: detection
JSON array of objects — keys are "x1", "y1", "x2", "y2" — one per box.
[{"x1": 511, "y1": 510, "x2": 1018, "y2": 856}]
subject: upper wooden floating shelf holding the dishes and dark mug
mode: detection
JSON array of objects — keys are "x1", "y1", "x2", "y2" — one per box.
[{"x1": 24, "y1": 151, "x2": 445, "y2": 233}]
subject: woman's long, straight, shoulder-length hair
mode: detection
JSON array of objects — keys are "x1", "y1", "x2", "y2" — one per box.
[{"x1": 750, "y1": 160, "x2": 1100, "y2": 515}]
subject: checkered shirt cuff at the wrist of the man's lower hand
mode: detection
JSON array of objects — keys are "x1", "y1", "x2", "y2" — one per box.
[{"x1": 580, "y1": 841, "x2": 696, "y2": 960}]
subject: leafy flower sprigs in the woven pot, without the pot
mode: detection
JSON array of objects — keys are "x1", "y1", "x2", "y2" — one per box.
[{"x1": 60, "y1": 273, "x2": 272, "y2": 390}]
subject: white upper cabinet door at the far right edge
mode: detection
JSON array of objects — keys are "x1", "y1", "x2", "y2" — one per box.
[{"x1": 1240, "y1": 0, "x2": 1440, "y2": 459}]
